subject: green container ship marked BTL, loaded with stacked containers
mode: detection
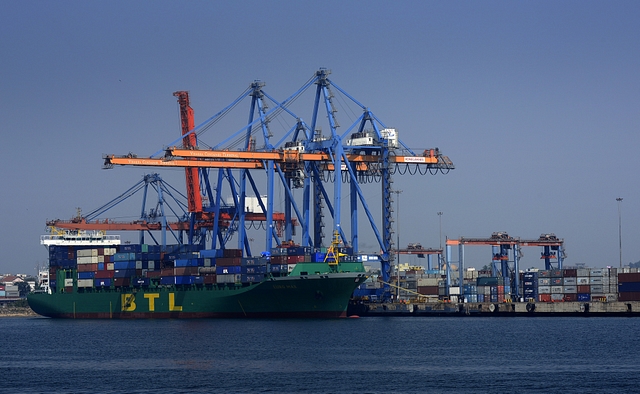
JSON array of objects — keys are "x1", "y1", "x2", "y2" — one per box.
[{"x1": 28, "y1": 232, "x2": 367, "y2": 319}]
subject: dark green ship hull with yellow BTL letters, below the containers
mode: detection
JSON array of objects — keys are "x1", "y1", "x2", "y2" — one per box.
[{"x1": 28, "y1": 263, "x2": 366, "y2": 319}]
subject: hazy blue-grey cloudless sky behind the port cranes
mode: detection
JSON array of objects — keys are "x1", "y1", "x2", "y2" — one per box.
[{"x1": 0, "y1": 0, "x2": 640, "y2": 273}]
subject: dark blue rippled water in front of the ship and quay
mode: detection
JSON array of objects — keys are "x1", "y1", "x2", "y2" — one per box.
[{"x1": 0, "y1": 317, "x2": 640, "y2": 393}]
